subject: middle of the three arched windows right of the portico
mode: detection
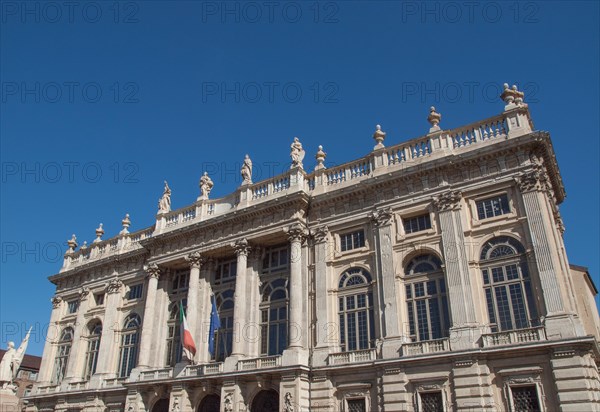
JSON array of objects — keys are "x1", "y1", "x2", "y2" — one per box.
[{"x1": 404, "y1": 254, "x2": 450, "y2": 342}]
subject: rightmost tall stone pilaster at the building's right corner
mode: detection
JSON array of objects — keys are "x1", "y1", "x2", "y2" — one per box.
[{"x1": 515, "y1": 170, "x2": 583, "y2": 338}]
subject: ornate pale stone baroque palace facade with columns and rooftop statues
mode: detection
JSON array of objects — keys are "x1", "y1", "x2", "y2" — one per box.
[{"x1": 27, "y1": 86, "x2": 600, "y2": 412}]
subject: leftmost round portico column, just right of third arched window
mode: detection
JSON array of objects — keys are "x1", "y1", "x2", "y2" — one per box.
[{"x1": 138, "y1": 263, "x2": 160, "y2": 368}]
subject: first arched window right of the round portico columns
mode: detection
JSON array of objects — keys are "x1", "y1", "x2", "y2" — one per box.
[{"x1": 338, "y1": 268, "x2": 375, "y2": 352}]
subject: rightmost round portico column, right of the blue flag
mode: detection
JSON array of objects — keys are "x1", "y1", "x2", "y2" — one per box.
[{"x1": 287, "y1": 223, "x2": 307, "y2": 349}]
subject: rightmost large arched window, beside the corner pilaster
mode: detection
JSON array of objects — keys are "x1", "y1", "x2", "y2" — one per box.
[{"x1": 480, "y1": 236, "x2": 539, "y2": 332}]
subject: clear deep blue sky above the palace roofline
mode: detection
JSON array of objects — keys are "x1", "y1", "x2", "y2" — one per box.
[{"x1": 0, "y1": 0, "x2": 600, "y2": 355}]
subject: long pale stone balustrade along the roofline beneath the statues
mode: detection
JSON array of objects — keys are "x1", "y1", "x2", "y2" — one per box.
[{"x1": 61, "y1": 107, "x2": 533, "y2": 272}]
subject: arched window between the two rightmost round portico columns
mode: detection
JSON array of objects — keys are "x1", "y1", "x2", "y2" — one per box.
[{"x1": 260, "y1": 278, "x2": 288, "y2": 355}]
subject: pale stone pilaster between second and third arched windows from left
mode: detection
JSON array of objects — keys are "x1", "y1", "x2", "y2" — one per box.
[{"x1": 96, "y1": 278, "x2": 123, "y2": 379}]
